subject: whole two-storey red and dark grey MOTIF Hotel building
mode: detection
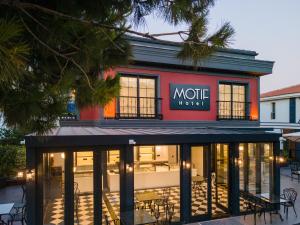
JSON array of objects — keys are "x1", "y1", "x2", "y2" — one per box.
[{"x1": 26, "y1": 38, "x2": 280, "y2": 225}]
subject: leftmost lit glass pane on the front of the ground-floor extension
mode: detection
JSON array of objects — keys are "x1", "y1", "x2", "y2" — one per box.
[{"x1": 43, "y1": 152, "x2": 65, "y2": 225}]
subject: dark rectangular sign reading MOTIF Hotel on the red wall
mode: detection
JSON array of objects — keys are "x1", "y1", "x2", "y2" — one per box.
[{"x1": 170, "y1": 84, "x2": 210, "y2": 111}]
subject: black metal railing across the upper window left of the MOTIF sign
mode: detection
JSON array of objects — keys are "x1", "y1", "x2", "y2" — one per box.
[{"x1": 107, "y1": 96, "x2": 162, "y2": 119}]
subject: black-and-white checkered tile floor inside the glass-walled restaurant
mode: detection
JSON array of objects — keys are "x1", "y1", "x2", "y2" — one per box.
[{"x1": 45, "y1": 184, "x2": 232, "y2": 225}]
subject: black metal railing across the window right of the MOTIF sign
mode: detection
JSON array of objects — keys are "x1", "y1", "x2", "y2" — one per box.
[{"x1": 217, "y1": 101, "x2": 252, "y2": 120}]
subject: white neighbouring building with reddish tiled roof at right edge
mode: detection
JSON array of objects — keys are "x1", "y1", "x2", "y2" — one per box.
[{"x1": 260, "y1": 84, "x2": 300, "y2": 160}]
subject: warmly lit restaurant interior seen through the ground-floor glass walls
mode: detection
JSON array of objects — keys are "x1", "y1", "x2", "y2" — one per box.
[{"x1": 43, "y1": 143, "x2": 272, "y2": 225}]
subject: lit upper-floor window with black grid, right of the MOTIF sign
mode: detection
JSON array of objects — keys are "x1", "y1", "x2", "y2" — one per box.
[{"x1": 218, "y1": 83, "x2": 249, "y2": 120}]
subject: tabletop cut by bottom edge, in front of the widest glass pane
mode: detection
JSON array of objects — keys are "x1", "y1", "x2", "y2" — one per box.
[{"x1": 121, "y1": 210, "x2": 156, "y2": 225}]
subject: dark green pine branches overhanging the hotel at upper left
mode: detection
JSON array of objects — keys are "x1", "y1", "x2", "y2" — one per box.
[{"x1": 0, "y1": 0, "x2": 234, "y2": 133}]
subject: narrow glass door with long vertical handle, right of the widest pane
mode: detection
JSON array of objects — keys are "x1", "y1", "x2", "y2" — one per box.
[{"x1": 212, "y1": 144, "x2": 229, "y2": 217}]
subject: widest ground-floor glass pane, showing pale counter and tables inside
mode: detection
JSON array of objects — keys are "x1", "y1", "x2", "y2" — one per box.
[{"x1": 134, "y1": 145, "x2": 180, "y2": 222}]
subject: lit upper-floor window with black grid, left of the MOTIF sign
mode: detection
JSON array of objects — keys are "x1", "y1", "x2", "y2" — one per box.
[{"x1": 117, "y1": 76, "x2": 158, "y2": 119}]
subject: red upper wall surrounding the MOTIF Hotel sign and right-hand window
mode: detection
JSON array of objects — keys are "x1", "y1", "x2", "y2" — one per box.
[{"x1": 109, "y1": 68, "x2": 258, "y2": 121}]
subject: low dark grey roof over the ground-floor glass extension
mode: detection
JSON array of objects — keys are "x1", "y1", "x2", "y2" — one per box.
[{"x1": 25, "y1": 126, "x2": 280, "y2": 148}]
